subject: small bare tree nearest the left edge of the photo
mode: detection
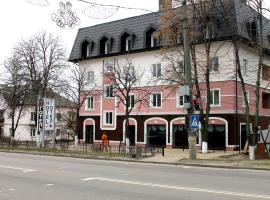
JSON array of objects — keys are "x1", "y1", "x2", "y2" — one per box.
[{"x1": 2, "y1": 54, "x2": 29, "y2": 144}]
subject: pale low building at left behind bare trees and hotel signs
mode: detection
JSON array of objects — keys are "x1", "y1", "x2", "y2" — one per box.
[{"x1": 0, "y1": 89, "x2": 76, "y2": 142}]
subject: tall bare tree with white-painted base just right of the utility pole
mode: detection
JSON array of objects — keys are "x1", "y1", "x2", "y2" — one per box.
[{"x1": 160, "y1": 0, "x2": 233, "y2": 152}]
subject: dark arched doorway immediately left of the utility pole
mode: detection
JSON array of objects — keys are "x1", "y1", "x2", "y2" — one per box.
[{"x1": 173, "y1": 125, "x2": 188, "y2": 148}]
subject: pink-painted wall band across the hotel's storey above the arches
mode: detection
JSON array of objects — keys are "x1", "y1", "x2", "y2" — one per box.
[{"x1": 80, "y1": 81, "x2": 270, "y2": 115}]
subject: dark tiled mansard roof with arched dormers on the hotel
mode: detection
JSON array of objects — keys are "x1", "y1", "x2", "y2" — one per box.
[{"x1": 69, "y1": 0, "x2": 270, "y2": 61}]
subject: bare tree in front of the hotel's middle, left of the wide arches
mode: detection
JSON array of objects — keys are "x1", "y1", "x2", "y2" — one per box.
[{"x1": 104, "y1": 57, "x2": 150, "y2": 152}]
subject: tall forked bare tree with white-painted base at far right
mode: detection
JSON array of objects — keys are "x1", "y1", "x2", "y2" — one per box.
[{"x1": 232, "y1": 0, "x2": 269, "y2": 159}]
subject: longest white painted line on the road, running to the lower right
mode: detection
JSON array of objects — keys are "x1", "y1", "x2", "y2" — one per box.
[{"x1": 81, "y1": 177, "x2": 270, "y2": 199}]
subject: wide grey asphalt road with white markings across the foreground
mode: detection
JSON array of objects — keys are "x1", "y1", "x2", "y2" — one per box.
[{"x1": 0, "y1": 153, "x2": 270, "y2": 200}]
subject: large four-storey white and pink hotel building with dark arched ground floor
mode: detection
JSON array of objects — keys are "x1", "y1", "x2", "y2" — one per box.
[{"x1": 70, "y1": 0, "x2": 270, "y2": 149}]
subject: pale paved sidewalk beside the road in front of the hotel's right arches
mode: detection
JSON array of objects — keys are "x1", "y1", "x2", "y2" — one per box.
[{"x1": 140, "y1": 149, "x2": 270, "y2": 170}]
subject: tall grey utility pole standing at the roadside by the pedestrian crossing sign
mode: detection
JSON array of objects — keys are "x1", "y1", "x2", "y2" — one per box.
[{"x1": 182, "y1": 0, "x2": 197, "y2": 160}]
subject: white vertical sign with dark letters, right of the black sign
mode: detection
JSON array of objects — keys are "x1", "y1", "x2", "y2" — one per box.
[{"x1": 43, "y1": 98, "x2": 55, "y2": 131}]
